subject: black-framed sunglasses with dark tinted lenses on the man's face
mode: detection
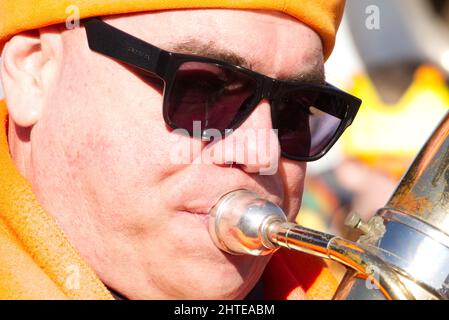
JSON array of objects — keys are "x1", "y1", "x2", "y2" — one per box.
[{"x1": 83, "y1": 18, "x2": 361, "y2": 161}]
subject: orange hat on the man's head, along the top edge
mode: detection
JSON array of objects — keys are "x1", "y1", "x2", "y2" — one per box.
[{"x1": 0, "y1": 0, "x2": 345, "y2": 58}]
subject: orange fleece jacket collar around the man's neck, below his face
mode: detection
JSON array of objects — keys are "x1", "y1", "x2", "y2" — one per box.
[{"x1": 0, "y1": 101, "x2": 337, "y2": 299}]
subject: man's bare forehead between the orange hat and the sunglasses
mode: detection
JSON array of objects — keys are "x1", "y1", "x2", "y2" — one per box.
[{"x1": 103, "y1": 10, "x2": 324, "y2": 83}]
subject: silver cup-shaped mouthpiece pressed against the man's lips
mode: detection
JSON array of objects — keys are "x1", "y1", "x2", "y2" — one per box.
[{"x1": 209, "y1": 190, "x2": 287, "y2": 256}]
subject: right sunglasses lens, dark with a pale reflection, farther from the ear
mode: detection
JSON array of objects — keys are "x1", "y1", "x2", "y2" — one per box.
[{"x1": 276, "y1": 89, "x2": 347, "y2": 158}]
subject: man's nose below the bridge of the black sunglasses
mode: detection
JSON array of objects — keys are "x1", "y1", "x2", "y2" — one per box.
[{"x1": 206, "y1": 100, "x2": 281, "y2": 175}]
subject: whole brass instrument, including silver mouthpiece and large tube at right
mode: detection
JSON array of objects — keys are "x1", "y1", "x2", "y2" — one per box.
[{"x1": 209, "y1": 113, "x2": 449, "y2": 300}]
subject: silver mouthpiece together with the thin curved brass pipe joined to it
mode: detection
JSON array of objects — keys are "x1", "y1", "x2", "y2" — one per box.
[{"x1": 209, "y1": 190, "x2": 414, "y2": 299}]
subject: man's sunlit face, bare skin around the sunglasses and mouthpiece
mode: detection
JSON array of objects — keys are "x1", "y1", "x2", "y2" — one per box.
[{"x1": 9, "y1": 10, "x2": 323, "y2": 299}]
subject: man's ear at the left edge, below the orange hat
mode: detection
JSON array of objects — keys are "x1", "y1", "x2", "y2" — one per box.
[{"x1": 0, "y1": 27, "x2": 62, "y2": 127}]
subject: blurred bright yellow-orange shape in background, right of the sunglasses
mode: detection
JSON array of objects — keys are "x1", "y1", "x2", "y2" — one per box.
[{"x1": 342, "y1": 65, "x2": 449, "y2": 178}]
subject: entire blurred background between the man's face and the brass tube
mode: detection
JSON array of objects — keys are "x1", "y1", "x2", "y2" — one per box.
[{"x1": 297, "y1": 0, "x2": 449, "y2": 275}]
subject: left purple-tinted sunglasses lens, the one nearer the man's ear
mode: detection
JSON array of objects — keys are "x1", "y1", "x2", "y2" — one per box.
[{"x1": 168, "y1": 62, "x2": 257, "y2": 133}]
